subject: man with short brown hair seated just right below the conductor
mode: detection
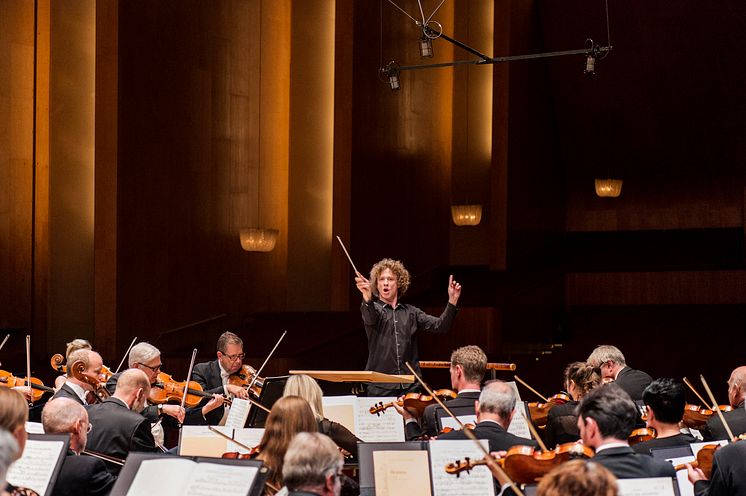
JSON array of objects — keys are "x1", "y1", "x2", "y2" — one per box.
[{"x1": 394, "y1": 345, "x2": 487, "y2": 440}]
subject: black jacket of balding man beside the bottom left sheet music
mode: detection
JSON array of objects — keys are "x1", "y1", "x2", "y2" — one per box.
[{"x1": 52, "y1": 451, "x2": 117, "y2": 496}]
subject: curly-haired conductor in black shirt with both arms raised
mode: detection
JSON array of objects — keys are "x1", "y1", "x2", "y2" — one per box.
[{"x1": 355, "y1": 258, "x2": 461, "y2": 396}]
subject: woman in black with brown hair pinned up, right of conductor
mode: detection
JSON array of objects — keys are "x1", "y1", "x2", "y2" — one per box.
[{"x1": 544, "y1": 362, "x2": 601, "y2": 449}]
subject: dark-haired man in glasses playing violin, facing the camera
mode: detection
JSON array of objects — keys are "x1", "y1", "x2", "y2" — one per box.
[{"x1": 192, "y1": 332, "x2": 249, "y2": 400}]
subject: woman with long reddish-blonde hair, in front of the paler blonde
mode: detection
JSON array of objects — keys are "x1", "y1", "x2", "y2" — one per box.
[{"x1": 256, "y1": 396, "x2": 318, "y2": 494}]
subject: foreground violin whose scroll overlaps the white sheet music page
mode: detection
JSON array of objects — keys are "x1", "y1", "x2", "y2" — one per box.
[{"x1": 445, "y1": 443, "x2": 594, "y2": 484}]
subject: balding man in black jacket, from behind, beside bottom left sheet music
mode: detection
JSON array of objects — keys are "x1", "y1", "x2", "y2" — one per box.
[{"x1": 42, "y1": 398, "x2": 116, "y2": 496}]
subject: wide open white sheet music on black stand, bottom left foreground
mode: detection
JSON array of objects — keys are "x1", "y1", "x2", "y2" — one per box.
[{"x1": 127, "y1": 458, "x2": 257, "y2": 496}]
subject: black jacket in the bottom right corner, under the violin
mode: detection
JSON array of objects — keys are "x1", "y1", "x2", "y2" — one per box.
[{"x1": 694, "y1": 441, "x2": 746, "y2": 496}]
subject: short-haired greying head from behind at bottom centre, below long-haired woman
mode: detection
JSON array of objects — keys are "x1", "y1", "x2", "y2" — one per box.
[{"x1": 282, "y1": 432, "x2": 343, "y2": 496}]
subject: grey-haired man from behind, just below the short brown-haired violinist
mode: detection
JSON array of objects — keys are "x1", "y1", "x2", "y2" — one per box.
[{"x1": 438, "y1": 380, "x2": 538, "y2": 452}]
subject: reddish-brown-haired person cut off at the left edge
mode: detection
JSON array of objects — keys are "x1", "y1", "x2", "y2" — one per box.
[{"x1": 0, "y1": 387, "x2": 39, "y2": 496}]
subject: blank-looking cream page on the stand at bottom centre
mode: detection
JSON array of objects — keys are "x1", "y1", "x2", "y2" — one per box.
[{"x1": 373, "y1": 451, "x2": 430, "y2": 496}]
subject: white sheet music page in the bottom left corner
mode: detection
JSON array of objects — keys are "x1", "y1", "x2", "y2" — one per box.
[{"x1": 6, "y1": 439, "x2": 65, "y2": 496}]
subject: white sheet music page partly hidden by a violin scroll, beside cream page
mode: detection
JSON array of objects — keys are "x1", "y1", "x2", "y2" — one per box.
[{"x1": 429, "y1": 439, "x2": 495, "y2": 496}]
